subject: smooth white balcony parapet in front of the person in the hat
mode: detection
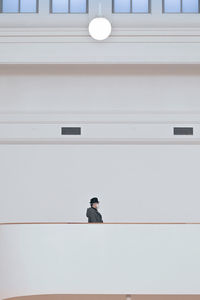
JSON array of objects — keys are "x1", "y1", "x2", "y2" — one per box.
[{"x1": 0, "y1": 224, "x2": 200, "y2": 299}]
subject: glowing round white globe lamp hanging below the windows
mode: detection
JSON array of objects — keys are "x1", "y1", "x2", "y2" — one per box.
[{"x1": 89, "y1": 17, "x2": 112, "y2": 41}]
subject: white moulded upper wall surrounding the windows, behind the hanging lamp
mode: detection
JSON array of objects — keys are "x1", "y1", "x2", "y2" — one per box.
[{"x1": 0, "y1": 0, "x2": 200, "y2": 64}]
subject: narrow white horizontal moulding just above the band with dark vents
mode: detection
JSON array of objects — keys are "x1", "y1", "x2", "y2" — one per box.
[{"x1": 0, "y1": 111, "x2": 200, "y2": 125}]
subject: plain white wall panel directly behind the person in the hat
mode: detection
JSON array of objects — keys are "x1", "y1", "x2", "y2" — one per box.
[{"x1": 0, "y1": 144, "x2": 200, "y2": 222}]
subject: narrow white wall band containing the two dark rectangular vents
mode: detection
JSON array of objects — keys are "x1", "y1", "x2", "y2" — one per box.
[{"x1": 0, "y1": 122, "x2": 200, "y2": 144}]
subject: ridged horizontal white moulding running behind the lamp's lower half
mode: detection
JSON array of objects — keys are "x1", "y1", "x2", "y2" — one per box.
[{"x1": 0, "y1": 28, "x2": 200, "y2": 44}]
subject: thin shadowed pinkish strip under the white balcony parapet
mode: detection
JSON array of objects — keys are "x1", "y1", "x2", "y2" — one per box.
[{"x1": 4, "y1": 295, "x2": 200, "y2": 300}]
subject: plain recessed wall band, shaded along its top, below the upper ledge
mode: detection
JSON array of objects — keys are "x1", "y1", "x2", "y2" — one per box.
[{"x1": 0, "y1": 65, "x2": 200, "y2": 113}]
